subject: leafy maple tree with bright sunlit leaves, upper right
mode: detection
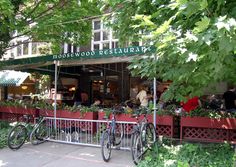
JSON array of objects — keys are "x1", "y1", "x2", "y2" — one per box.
[{"x1": 103, "y1": 0, "x2": 236, "y2": 100}]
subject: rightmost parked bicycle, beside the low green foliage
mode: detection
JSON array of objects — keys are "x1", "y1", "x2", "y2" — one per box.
[{"x1": 131, "y1": 108, "x2": 156, "y2": 165}]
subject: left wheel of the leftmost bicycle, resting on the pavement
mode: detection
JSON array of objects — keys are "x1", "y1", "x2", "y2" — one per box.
[{"x1": 7, "y1": 124, "x2": 27, "y2": 150}]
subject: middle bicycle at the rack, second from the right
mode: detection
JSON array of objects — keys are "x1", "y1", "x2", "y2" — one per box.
[{"x1": 101, "y1": 109, "x2": 124, "y2": 162}]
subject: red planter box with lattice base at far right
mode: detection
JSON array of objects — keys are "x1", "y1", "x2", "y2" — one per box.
[{"x1": 180, "y1": 117, "x2": 236, "y2": 143}]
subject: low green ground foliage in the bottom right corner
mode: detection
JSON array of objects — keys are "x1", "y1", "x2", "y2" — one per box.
[{"x1": 138, "y1": 141, "x2": 236, "y2": 167}]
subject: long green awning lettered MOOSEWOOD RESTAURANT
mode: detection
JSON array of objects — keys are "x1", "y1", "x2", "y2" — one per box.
[{"x1": 0, "y1": 46, "x2": 155, "y2": 70}]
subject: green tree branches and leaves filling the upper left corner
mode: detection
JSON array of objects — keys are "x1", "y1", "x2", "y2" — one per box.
[{"x1": 0, "y1": 0, "x2": 100, "y2": 57}]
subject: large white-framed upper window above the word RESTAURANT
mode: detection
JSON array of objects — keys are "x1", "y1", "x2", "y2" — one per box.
[{"x1": 91, "y1": 19, "x2": 118, "y2": 50}]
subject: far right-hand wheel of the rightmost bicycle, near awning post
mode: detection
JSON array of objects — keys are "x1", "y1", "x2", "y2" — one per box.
[{"x1": 145, "y1": 123, "x2": 156, "y2": 148}]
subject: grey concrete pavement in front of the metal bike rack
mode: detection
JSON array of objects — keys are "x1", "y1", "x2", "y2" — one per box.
[{"x1": 0, "y1": 142, "x2": 135, "y2": 167}]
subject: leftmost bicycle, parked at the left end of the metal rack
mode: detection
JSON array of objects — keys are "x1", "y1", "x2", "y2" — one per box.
[{"x1": 7, "y1": 109, "x2": 48, "y2": 150}]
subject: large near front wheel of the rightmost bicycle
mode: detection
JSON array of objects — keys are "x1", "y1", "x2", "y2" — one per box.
[{"x1": 131, "y1": 131, "x2": 143, "y2": 165}]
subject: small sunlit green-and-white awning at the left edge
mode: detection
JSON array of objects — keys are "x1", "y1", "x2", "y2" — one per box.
[{"x1": 0, "y1": 70, "x2": 30, "y2": 86}]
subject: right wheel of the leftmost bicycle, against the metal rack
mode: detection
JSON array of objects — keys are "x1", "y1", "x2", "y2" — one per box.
[{"x1": 35, "y1": 119, "x2": 48, "y2": 141}]
